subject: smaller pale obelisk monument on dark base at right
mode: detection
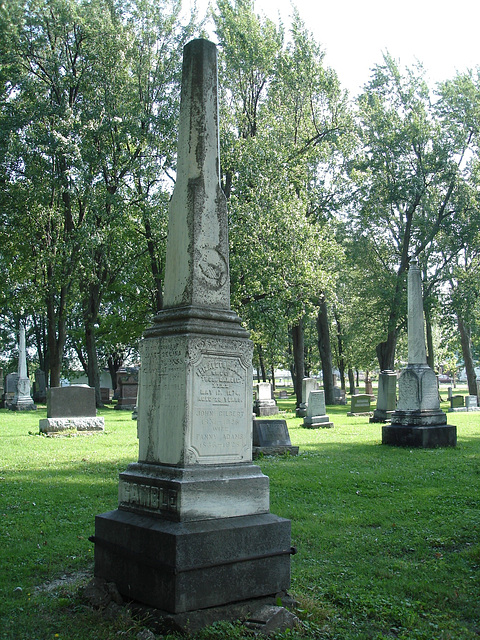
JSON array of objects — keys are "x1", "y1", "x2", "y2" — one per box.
[{"x1": 382, "y1": 260, "x2": 457, "y2": 448}]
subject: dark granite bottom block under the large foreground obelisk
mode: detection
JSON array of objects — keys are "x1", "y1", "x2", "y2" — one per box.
[{"x1": 94, "y1": 509, "x2": 291, "y2": 613}]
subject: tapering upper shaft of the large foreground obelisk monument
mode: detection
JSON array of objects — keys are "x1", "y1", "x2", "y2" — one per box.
[{"x1": 164, "y1": 40, "x2": 230, "y2": 309}]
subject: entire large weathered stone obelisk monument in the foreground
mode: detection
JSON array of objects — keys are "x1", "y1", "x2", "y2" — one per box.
[{"x1": 94, "y1": 40, "x2": 291, "y2": 614}]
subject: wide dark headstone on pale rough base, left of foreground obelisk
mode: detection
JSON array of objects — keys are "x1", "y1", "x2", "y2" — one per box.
[{"x1": 39, "y1": 385, "x2": 105, "y2": 434}]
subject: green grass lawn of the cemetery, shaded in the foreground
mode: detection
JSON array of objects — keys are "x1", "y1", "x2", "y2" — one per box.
[{"x1": 0, "y1": 389, "x2": 480, "y2": 640}]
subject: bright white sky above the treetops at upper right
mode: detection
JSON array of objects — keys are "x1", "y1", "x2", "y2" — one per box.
[{"x1": 184, "y1": 0, "x2": 480, "y2": 95}]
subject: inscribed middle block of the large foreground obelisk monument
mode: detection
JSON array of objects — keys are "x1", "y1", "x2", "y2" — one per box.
[{"x1": 138, "y1": 336, "x2": 253, "y2": 466}]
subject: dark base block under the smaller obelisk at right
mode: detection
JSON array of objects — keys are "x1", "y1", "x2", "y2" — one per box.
[{"x1": 382, "y1": 424, "x2": 457, "y2": 449}]
